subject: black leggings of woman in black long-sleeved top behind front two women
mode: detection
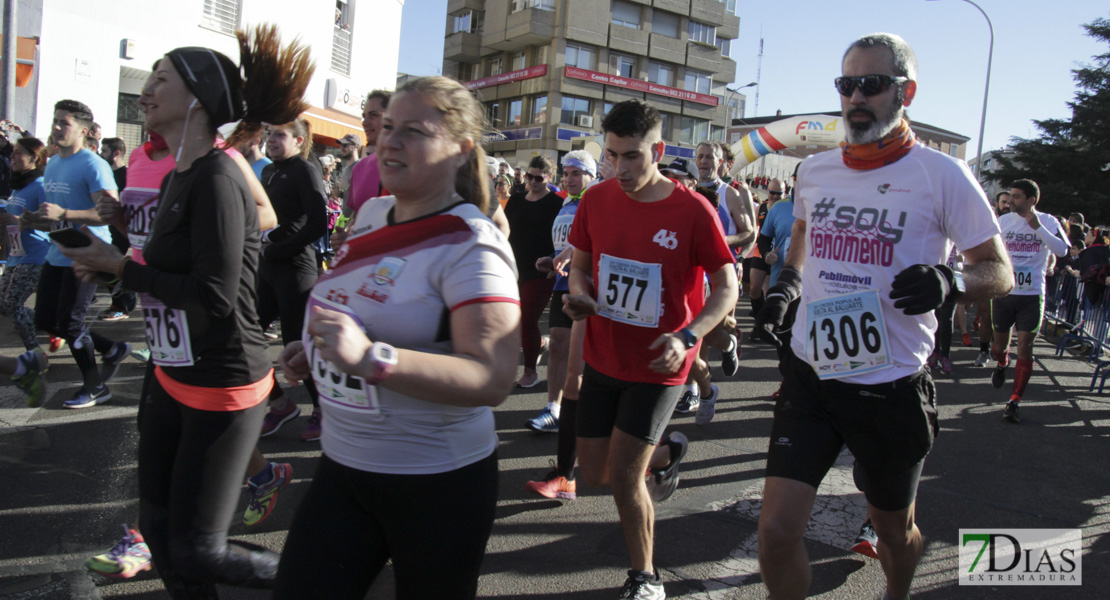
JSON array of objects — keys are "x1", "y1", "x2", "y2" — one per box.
[{"x1": 258, "y1": 260, "x2": 320, "y2": 407}]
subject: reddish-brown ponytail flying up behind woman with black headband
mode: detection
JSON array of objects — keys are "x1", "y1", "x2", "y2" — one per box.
[{"x1": 226, "y1": 24, "x2": 316, "y2": 153}]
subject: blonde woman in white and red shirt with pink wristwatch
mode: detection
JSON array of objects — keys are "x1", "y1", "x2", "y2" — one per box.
[{"x1": 274, "y1": 77, "x2": 521, "y2": 600}]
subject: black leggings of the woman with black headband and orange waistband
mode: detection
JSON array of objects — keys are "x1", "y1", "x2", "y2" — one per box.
[{"x1": 139, "y1": 377, "x2": 279, "y2": 600}]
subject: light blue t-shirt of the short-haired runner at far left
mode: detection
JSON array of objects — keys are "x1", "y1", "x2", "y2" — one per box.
[{"x1": 42, "y1": 148, "x2": 115, "y2": 266}]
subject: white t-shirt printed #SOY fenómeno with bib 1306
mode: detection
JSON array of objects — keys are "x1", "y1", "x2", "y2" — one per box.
[{"x1": 791, "y1": 144, "x2": 999, "y2": 384}]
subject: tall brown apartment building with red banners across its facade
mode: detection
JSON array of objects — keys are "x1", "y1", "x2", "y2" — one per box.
[{"x1": 443, "y1": 0, "x2": 744, "y2": 166}]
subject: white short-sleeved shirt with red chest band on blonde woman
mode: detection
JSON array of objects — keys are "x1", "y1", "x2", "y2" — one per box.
[{"x1": 304, "y1": 196, "x2": 519, "y2": 475}]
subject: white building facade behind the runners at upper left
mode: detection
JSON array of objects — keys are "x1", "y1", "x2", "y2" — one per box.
[{"x1": 10, "y1": 0, "x2": 404, "y2": 157}]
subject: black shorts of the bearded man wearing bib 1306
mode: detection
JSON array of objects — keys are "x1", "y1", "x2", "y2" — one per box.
[{"x1": 767, "y1": 350, "x2": 939, "y2": 510}]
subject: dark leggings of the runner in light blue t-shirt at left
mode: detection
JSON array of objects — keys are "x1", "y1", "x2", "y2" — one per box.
[{"x1": 34, "y1": 264, "x2": 115, "y2": 390}]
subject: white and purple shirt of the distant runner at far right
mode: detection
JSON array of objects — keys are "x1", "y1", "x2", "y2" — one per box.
[{"x1": 998, "y1": 209, "x2": 1071, "y2": 296}]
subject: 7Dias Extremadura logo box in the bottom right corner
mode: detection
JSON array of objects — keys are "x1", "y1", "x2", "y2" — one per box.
[{"x1": 959, "y1": 529, "x2": 1083, "y2": 586}]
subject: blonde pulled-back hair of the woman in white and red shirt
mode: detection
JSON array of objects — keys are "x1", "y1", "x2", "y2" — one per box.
[{"x1": 394, "y1": 75, "x2": 490, "y2": 214}]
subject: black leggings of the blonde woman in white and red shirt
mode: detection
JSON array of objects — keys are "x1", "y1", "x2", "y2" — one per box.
[{"x1": 274, "y1": 451, "x2": 497, "y2": 600}]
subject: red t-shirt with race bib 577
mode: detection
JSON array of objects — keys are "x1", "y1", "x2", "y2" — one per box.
[{"x1": 568, "y1": 180, "x2": 734, "y2": 385}]
